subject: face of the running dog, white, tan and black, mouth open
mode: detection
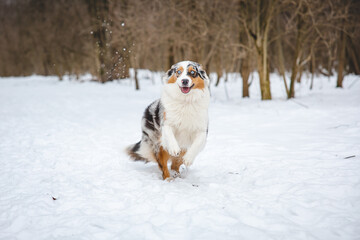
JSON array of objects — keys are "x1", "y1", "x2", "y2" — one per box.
[{"x1": 166, "y1": 61, "x2": 209, "y2": 94}]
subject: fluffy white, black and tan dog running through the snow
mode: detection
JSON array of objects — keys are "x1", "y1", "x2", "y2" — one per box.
[{"x1": 126, "y1": 61, "x2": 210, "y2": 180}]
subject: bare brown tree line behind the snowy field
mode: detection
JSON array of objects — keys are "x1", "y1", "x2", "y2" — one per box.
[{"x1": 0, "y1": 0, "x2": 360, "y2": 100}]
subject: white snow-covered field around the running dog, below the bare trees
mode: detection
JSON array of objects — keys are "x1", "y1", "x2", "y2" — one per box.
[{"x1": 0, "y1": 72, "x2": 360, "y2": 240}]
